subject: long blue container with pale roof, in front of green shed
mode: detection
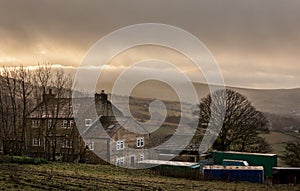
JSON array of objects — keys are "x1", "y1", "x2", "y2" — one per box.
[{"x1": 203, "y1": 165, "x2": 264, "y2": 183}]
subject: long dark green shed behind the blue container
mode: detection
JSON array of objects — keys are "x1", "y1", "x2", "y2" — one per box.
[{"x1": 212, "y1": 151, "x2": 277, "y2": 177}]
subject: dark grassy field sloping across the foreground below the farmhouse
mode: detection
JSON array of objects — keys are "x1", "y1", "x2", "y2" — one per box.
[{"x1": 0, "y1": 163, "x2": 300, "y2": 191}]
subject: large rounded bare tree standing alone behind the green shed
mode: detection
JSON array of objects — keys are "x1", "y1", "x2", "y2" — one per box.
[{"x1": 199, "y1": 89, "x2": 270, "y2": 152}]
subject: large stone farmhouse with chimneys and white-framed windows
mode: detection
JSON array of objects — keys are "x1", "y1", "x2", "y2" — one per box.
[{"x1": 25, "y1": 90, "x2": 149, "y2": 165}]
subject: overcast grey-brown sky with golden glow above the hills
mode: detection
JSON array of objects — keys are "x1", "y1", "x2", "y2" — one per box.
[{"x1": 0, "y1": 0, "x2": 300, "y2": 89}]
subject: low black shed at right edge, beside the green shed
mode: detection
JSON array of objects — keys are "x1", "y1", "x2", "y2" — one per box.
[{"x1": 272, "y1": 167, "x2": 300, "y2": 184}]
